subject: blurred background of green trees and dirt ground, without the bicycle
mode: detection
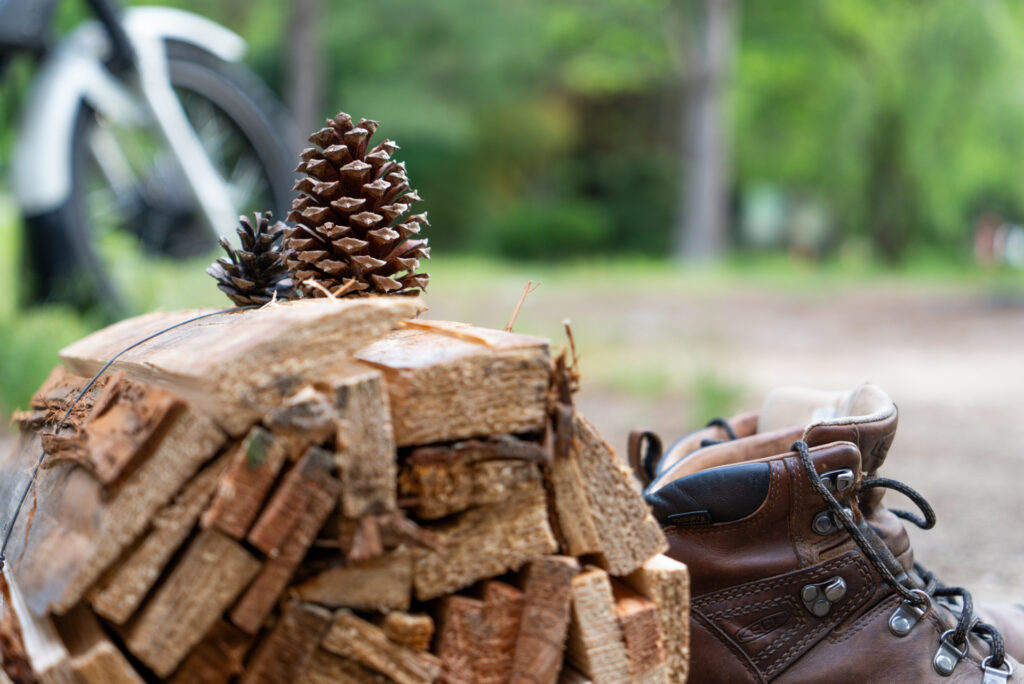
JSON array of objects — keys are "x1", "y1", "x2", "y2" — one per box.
[{"x1": 0, "y1": 0, "x2": 1024, "y2": 600}]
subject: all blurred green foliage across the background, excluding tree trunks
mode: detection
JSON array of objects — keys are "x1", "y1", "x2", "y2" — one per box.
[{"x1": 8, "y1": 0, "x2": 1024, "y2": 260}]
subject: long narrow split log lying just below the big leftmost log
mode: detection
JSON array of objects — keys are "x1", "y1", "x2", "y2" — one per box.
[{"x1": 89, "y1": 448, "x2": 228, "y2": 625}]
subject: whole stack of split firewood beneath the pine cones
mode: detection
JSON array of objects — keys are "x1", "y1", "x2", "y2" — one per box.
[{"x1": 0, "y1": 297, "x2": 688, "y2": 684}]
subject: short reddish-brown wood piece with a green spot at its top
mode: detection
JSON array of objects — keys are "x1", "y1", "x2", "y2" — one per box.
[{"x1": 202, "y1": 426, "x2": 304, "y2": 540}]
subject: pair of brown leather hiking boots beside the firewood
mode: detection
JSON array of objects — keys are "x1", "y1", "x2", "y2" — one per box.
[{"x1": 633, "y1": 385, "x2": 1024, "y2": 684}]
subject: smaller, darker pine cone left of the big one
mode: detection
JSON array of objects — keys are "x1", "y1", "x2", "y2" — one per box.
[{"x1": 206, "y1": 212, "x2": 294, "y2": 306}]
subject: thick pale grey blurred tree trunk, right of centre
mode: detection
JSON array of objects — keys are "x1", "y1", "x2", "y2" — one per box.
[{"x1": 674, "y1": 0, "x2": 734, "y2": 262}]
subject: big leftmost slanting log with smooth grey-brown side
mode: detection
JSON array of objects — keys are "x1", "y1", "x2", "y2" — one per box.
[{"x1": 0, "y1": 403, "x2": 224, "y2": 614}]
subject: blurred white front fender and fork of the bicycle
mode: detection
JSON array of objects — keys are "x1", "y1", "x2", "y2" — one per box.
[{"x1": 11, "y1": 7, "x2": 246, "y2": 237}]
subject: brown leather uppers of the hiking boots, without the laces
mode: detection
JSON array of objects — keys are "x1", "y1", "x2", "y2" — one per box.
[{"x1": 646, "y1": 382, "x2": 1024, "y2": 682}]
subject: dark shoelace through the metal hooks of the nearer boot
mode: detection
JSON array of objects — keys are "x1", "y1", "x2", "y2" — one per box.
[{"x1": 792, "y1": 441, "x2": 1009, "y2": 670}]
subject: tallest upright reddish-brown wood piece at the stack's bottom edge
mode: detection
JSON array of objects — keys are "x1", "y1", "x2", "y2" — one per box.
[{"x1": 509, "y1": 556, "x2": 580, "y2": 684}]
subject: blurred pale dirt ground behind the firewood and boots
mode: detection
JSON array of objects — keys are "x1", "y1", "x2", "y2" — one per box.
[{"x1": 0, "y1": 274, "x2": 1024, "y2": 601}]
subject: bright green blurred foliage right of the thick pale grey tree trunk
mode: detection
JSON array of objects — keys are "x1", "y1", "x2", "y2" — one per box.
[{"x1": 733, "y1": 0, "x2": 1024, "y2": 260}]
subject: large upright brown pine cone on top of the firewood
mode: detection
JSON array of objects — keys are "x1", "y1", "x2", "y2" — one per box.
[{"x1": 284, "y1": 112, "x2": 430, "y2": 297}]
